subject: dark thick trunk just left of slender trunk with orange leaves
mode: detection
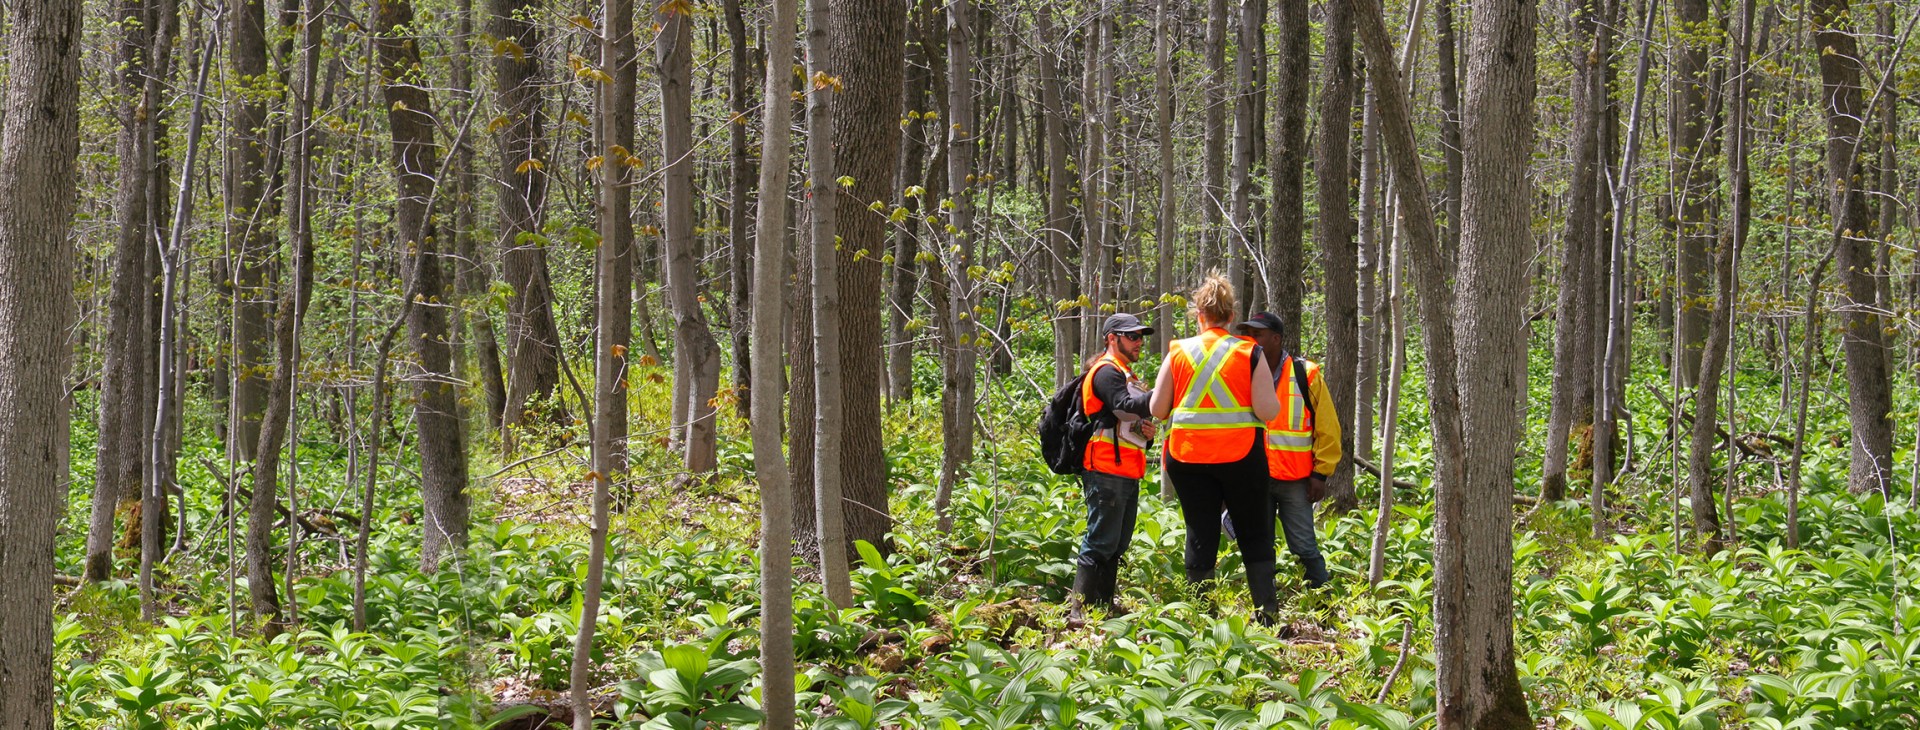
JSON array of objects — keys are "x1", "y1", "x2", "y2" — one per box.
[{"x1": 490, "y1": 0, "x2": 560, "y2": 434}]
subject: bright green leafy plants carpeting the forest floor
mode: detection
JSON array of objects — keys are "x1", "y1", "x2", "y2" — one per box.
[{"x1": 56, "y1": 351, "x2": 1920, "y2": 730}]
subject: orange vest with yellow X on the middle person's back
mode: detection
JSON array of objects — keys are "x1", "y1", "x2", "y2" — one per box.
[{"x1": 1164, "y1": 327, "x2": 1261, "y2": 463}]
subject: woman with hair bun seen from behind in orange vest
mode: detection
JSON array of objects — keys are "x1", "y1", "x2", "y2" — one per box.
[{"x1": 1152, "y1": 273, "x2": 1281, "y2": 622}]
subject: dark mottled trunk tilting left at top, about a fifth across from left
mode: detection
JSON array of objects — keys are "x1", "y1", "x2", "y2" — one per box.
[{"x1": 374, "y1": 0, "x2": 468, "y2": 571}]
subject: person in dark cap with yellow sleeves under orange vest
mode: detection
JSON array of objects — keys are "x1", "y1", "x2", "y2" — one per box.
[{"x1": 1240, "y1": 311, "x2": 1340, "y2": 588}]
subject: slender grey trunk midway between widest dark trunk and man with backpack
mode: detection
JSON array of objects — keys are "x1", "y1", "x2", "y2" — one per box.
[{"x1": 933, "y1": 0, "x2": 983, "y2": 532}]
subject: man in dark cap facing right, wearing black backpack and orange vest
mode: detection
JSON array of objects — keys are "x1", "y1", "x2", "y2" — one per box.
[{"x1": 1069, "y1": 313, "x2": 1154, "y2": 619}]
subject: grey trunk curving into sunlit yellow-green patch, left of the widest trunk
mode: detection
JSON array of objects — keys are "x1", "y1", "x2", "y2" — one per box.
[{"x1": 655, "y1": 4, "x2": 720, "y2": 478}]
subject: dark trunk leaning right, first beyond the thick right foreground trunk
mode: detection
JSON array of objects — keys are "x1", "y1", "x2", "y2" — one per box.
[{"x1": 1540, "y1": 0, "x2": 1617, "y2": 503}]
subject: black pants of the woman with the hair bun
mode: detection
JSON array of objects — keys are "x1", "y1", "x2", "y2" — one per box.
[{"x1": 1165, "y1": 432, "x2": 1273, "y2": 580}]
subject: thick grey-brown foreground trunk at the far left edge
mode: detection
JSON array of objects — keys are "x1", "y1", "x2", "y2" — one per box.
[{"x1": 0, "y1": 0, "x2": 83, "y2": 718}]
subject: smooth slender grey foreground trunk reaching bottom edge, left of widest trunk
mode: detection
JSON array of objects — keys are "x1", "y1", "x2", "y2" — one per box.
[{"x1": 749, "y1": 0, "x2": 804, "y2": 718}]
